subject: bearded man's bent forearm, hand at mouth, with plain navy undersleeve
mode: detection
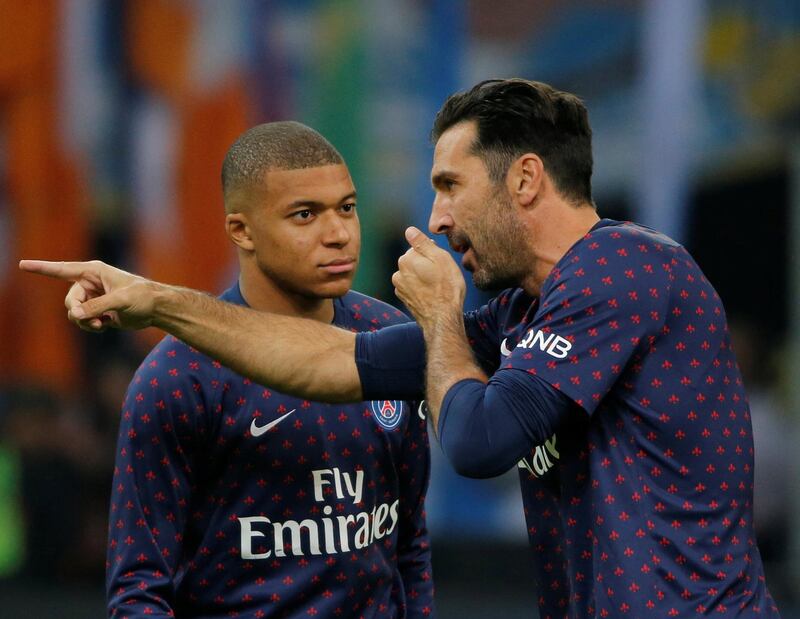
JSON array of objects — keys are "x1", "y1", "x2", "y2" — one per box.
[{"x1": 392, "y1": 228, "x2": 572, "y2": 477}]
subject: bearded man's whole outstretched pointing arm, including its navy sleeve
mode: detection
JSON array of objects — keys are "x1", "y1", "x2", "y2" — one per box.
[{"x1": 20, "y1": 260, "x2": 499, "y2": 402}]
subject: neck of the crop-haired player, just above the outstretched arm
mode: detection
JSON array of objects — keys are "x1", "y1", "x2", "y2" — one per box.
[{"x1": 239, "y1": 262, "x2": 334, "y2": 323}]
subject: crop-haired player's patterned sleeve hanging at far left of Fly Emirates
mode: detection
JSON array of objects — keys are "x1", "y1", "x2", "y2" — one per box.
[{"x1": 106, "y1": 337, "x2": 213, "y2": 619}]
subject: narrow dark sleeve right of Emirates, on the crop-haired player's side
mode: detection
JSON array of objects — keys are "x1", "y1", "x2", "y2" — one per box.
[{"x1": 397, "y1": 402, "x2": 435, "y2": 619}]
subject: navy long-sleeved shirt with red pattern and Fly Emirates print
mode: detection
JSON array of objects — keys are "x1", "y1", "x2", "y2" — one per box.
[{"x1": 107, "y1": 286, "x2": 434, "y2": 619}]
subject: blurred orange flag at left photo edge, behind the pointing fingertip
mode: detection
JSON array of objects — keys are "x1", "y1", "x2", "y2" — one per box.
[{"x1": 0, "y1": 0, "x2": 87, "y2": 391}]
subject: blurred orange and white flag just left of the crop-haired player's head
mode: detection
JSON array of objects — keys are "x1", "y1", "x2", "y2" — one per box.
[{"x1": 126, "y1": 0, "x2": 249, "y2": 348}]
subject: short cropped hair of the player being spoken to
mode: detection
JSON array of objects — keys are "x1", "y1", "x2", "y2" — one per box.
[{"x1": 222, "y1": 121, "x2": 344, "y2": 210}]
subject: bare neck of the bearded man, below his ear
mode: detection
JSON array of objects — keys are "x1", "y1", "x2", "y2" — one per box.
[{"x1": 521, "y1": 200, "x2": 600, "y2": 296}]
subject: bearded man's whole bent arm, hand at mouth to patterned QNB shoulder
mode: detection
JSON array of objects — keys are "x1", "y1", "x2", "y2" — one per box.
[{"x1": 395, "y1": 232, "x2": 670, "y2": 477}]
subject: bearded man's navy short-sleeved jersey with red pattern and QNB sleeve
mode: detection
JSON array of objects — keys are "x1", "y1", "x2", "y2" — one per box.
[{"x1": 466, "y1": 220, "x2": 778, "y2": 619}]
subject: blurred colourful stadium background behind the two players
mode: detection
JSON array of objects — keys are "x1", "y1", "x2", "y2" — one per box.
[{"x1": 0, "y1": 0, "x2": 800, "y2": 619}]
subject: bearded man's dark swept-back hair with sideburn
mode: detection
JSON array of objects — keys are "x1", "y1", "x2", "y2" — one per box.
[{"x1": 431, "y1": 79, "x2": 592, "y2": 203}]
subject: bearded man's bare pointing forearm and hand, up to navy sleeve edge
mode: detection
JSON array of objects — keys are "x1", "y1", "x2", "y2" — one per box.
[{"x1": 20, "y1": 260, "x2": 363, "y2": 402}]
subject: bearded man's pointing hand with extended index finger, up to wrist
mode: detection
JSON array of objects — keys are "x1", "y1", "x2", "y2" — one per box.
[{"x1": 19, "y1": 260, "x2": 164, "y2": 332}]
